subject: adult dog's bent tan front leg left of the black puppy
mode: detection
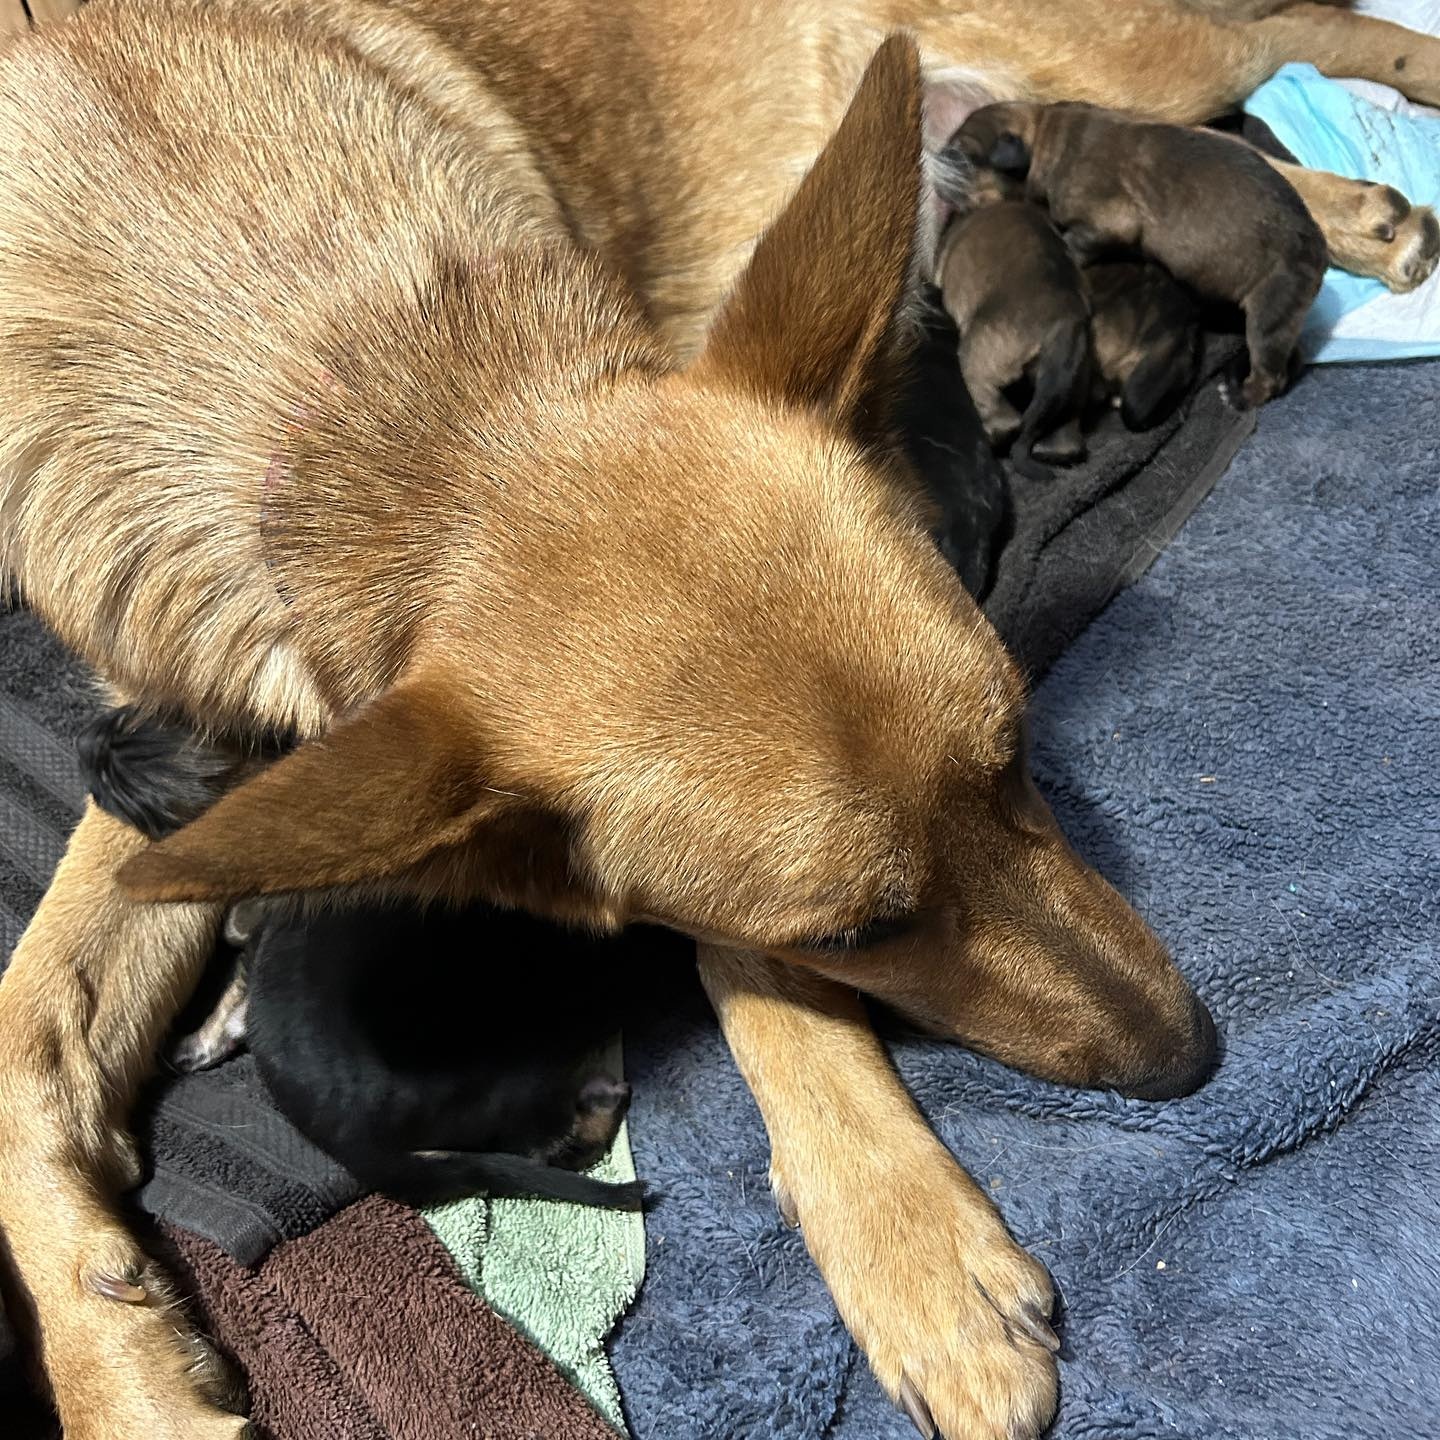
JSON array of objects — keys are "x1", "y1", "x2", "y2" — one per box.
[{"x1": 0, "y1": 806, "x2": 243, "y2": 1440}]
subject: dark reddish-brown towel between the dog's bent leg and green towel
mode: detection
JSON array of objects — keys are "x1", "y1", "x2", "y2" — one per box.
[{"x1": 164, "y1": 1195, "x2": 615, "y2": 1440}]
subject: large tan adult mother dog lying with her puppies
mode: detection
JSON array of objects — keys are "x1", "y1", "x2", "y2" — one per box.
[{"x1": 0, "y1": 0, "x2": 1440, "y2": 1440}]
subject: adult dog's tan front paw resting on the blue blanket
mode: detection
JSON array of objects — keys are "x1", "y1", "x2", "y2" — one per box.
[{"x1": 775, "y1": 1139, "x2": 1058, "y2": 1440}]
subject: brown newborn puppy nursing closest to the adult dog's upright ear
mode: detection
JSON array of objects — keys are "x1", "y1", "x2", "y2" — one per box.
[{"x1": 936, "y1": 187, "x2": 1090, "y2": 478}]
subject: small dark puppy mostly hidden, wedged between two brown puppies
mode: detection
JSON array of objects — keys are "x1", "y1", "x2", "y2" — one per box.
[{"x1": 1081, "y1": 261, "x2": 1202, "y2": 431}]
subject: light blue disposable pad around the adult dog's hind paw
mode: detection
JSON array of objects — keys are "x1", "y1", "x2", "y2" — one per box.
[{"x1": 1246, "y1": 65, "x2": 1440, "y2": 361}]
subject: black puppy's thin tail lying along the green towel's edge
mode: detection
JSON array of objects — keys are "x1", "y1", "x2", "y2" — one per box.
[{"x1": 377, "y1": 1151, "x2": 645, "y2": 1210}]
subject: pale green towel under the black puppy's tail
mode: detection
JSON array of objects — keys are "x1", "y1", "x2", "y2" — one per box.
[{"x1": 423, "y1": 1042, "x2": 645, "y2": 1434}]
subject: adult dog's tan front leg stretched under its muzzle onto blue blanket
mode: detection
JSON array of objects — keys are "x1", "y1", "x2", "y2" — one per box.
[{"x1": 700, "y1": 946, "x2": 1056, "y2": 1440}]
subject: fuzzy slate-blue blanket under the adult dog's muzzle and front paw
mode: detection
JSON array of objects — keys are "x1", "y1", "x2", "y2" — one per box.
[{"x1": 611, "y1": 364, "x2": 1440, "y2": 1440}]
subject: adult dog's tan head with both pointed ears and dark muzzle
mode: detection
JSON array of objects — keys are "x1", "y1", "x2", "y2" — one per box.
[{"x1": 121, "y1": 39, "x2": 1214, "y2": 1094}]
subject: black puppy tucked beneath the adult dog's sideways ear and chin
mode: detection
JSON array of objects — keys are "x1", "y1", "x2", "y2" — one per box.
[{"x1": 81, "y1": 710, "x2": 644, "y2": 1207}]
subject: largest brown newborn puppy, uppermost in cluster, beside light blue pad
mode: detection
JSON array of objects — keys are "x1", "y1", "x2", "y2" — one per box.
[{"x1": 952, "y1": 104, "x2": 1326, "y2": 408}]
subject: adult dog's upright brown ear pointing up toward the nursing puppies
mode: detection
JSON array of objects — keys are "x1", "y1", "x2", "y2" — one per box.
[{"x1": 694, "y1": 35, "x2": 923, "y2": 441}]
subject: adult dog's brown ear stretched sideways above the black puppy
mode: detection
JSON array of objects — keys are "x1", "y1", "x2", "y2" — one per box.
[{"x1": 120, "y1": 683, "x2": 524, "y2": 900}]
